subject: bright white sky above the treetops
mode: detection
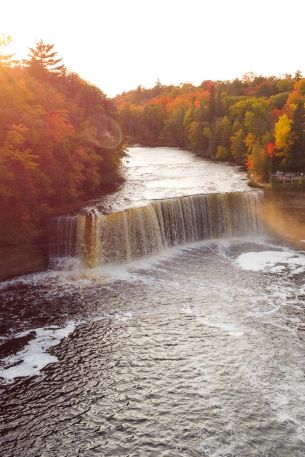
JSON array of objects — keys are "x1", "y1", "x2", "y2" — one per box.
[{"x1": 0, "y1": 0, "x2": 305, "y2": 96}]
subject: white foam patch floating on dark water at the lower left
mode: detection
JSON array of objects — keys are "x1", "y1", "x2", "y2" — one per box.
[{"x1": 0, "y1": 321, "x2": 76, "y2": 383}]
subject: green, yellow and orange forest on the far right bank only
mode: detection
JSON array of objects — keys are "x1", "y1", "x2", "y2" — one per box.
[{"x1": 114, "y1": 71, "x2": 305, "y2": 182}]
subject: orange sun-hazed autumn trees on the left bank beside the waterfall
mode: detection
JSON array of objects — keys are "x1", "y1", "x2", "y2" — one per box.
[{"x1": 0, "y1": 37, "x2": 123, "y2": 246}]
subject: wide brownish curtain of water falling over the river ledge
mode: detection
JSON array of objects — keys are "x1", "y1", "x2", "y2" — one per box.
[{"x1": 50, "y1": 191, "x2": 262, "y2": 267}]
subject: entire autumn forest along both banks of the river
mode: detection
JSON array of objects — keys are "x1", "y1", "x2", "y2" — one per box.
[{"x1": 0, "y1": 36, "x2": 305, "y2": 253}]
